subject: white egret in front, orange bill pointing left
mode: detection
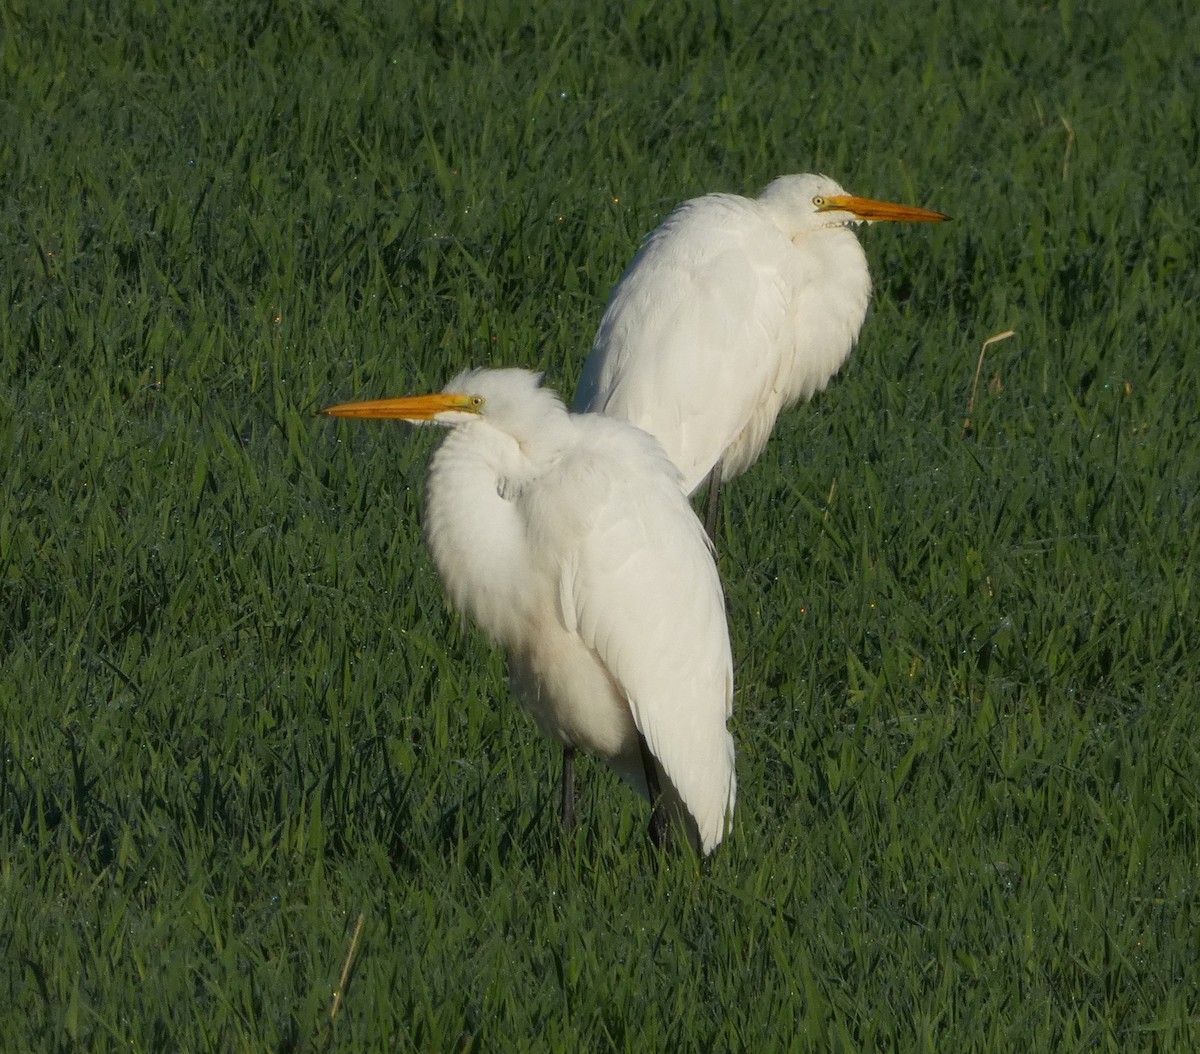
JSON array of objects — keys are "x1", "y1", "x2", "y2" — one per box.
[{"x1": 323, "y1": 370, "x2": 736, "y2": 854}]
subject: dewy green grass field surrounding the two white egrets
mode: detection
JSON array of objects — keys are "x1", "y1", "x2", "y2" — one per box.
[{"x1": 0, "y1": 0, "x2": 1200, "y2": 1052}]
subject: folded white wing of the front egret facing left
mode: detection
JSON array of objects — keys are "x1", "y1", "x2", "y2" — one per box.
[{"x1": 530, "y1": 417, "x2": 736, "y2": 852}]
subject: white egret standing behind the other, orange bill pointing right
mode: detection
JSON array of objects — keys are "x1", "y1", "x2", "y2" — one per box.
[{"x1": 574, "y1": 175, "x2": 949, "y2": 537}]
